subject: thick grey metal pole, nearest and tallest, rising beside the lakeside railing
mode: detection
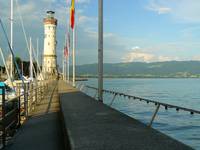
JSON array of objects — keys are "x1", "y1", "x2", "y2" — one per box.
[{"x1": 98, "y1": 0, "x2": 103, "y2": 102}]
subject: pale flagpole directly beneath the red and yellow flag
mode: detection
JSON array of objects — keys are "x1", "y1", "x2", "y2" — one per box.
[{"x1": 72, "y1": 26, "x2": 76, "y2": 87}]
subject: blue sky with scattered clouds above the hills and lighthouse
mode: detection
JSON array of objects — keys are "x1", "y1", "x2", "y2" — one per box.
[{"x1": 0, "y1": 0, "x2": 200, "y2": 65}]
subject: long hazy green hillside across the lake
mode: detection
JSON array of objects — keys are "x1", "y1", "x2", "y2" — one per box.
[{"x1": 76, "y1": 61, "x2": 200, "y2": 78}]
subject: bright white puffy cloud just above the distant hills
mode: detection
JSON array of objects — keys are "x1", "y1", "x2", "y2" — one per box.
[{"x1": 122, "y1": 46, "x2": 179, "y2": 62}]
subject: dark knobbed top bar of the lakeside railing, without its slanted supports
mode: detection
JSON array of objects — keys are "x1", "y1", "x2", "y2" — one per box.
[{"x1": 85, "y1": 86, "x2": 200, "y2": 114}]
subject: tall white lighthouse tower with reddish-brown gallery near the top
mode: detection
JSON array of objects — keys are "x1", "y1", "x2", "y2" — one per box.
[{"x1": 42, "y1": 11, "x2": 58, "y2": 79}]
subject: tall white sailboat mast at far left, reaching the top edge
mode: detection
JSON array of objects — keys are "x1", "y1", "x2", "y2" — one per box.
[{"x1": 10, "y1": 0, "x2": 13, "y2": 78}]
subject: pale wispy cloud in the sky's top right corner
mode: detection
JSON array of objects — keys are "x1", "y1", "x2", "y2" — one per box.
[{"x1": 146, "y1": 0, "x2": 200, "y2": 23}]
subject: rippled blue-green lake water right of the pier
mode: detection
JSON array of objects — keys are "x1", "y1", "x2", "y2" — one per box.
[{"x1": 78, "y1": 79, "x2": 200, "y2": 150}]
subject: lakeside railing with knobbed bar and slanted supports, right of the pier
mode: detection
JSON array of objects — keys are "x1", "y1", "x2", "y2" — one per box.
[{"x1": 77, "y1": 84, "x2": 200, "y2": 127}]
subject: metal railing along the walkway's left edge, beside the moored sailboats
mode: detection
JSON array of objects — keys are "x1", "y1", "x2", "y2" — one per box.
[{"x1": 0, "y1": 81, "x2": 48, "y2": 148}]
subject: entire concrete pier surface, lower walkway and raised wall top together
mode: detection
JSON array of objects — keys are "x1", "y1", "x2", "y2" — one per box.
[{"x1": 3, "y1": 81, "x2": 192, "y2": 150}]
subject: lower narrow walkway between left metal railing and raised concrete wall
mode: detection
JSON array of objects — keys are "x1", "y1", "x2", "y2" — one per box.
[{"x1": 6, "y1": 82, "x2": 64, "y2": 150}]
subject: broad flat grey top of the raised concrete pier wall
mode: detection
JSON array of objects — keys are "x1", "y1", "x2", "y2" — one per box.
[{"x1": 60, "y1": 85, "x2": 192, "y2": 150}]
